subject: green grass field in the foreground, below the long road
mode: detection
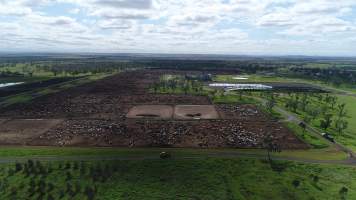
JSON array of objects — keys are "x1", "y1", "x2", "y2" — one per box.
[{"x1": 0, "y1": 158, "x2": 356, "y2": 200}]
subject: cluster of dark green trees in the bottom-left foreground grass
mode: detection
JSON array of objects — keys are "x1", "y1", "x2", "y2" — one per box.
[{"x1": 0, "y1": 160, "x2": 98, "y2": 200}]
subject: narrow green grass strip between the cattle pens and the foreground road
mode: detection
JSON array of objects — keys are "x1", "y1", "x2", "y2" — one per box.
[{"x1": 0, "y1": 147, "x2": 347, "y2": 161}]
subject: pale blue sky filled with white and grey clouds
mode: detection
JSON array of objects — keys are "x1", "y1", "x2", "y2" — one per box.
[{"x1": 0, "y1": 0, "x2": 356, "y2": 56}]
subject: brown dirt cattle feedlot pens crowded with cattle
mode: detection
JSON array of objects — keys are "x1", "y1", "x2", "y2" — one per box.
[{"x1": 0, "y1": 70, "x2": 308, "y2": 149}]
